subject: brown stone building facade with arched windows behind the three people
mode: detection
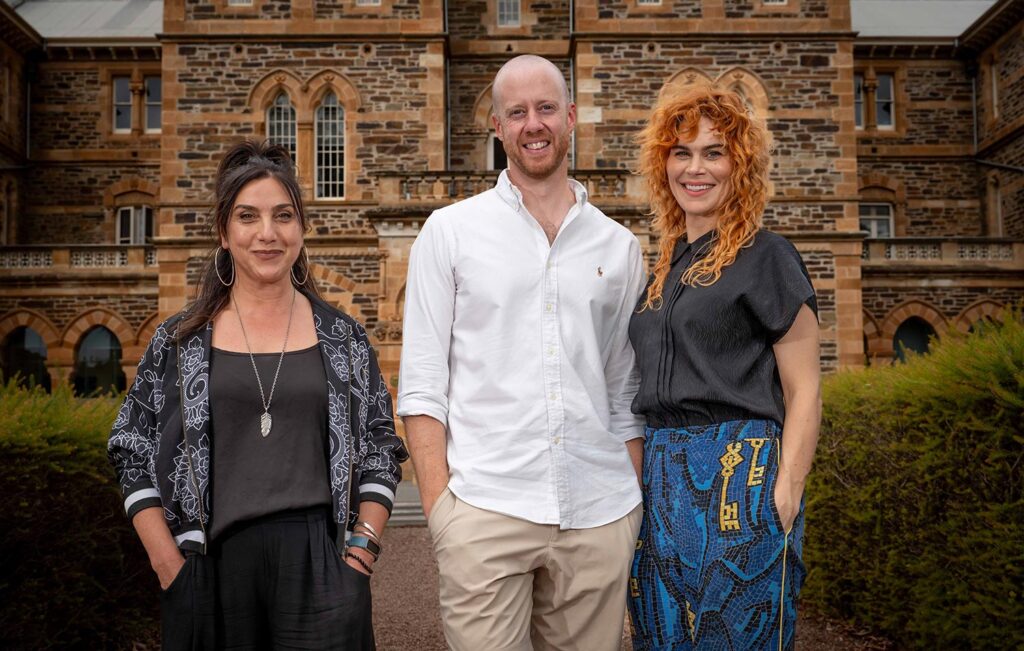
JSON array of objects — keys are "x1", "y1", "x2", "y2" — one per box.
[{"x1": 0, "y1": 0, "x2": 1024, "y2": 399}]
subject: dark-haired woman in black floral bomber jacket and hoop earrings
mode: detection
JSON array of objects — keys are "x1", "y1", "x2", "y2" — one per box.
[{"x1": 109, "y1": 142, "x2": 408, "y2": 651}]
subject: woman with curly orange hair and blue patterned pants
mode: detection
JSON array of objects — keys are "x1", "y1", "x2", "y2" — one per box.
[{"x1": 630, "y1": 87, "x2": 821, "y2": 651}]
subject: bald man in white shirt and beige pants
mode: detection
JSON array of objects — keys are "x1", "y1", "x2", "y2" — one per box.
[{"x1": 398, "y1": 55, "x2": 643, "y2": 651}]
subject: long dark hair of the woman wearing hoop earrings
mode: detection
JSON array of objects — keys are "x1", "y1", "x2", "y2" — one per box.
[{"x1": 178, "y1": 140, "x2": 319, "y2": 338}]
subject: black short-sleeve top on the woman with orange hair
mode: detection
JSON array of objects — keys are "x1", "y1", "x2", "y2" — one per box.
[{"x1": 630, "y1": 230, "x2": 817, "y2": 428}]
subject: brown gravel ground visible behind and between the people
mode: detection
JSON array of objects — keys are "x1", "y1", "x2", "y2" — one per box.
[{"x1": 372, "y1": 526, "x2": 892, "y2": 651}]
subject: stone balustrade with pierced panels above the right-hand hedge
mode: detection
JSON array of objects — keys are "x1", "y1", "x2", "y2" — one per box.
[{"x1": 861, "y1": 237, "x2": 1024, "y2": 269}]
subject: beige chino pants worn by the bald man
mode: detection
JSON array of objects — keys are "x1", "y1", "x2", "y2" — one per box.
[{"x1": 427, "y1": 488, "x2": 642, "y2": 651}]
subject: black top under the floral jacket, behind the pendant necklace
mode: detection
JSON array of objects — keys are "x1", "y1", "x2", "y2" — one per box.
[{"x1": 210, "y1": 345, "x2": 331, "y2": 540}]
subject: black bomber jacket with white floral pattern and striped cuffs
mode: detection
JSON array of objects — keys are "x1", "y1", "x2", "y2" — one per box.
[{"x1": 108, "y1": 296, "x2": 409, "y2": 553}]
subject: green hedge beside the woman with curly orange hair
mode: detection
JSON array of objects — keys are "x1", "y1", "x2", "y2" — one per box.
[{"x1": 803, "y1": 312, "x2": 1024, "y2": 649}]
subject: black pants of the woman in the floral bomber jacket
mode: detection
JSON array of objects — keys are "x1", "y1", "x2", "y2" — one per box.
[{"x1": 161, "y1": 509, "x2": 375, "y2": 651}]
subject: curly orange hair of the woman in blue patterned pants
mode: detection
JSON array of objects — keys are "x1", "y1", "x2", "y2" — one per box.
[{"x1": 637, "y1": 86, "x2": 771, "y2": 309}]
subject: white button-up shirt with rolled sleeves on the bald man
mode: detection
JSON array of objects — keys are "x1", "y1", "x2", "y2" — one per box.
[{"x1": 398, "y1": 172, "x2": 643, "y2": 529}]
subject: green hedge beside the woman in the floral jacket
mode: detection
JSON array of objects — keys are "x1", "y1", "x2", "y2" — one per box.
[{"x1": 0, "y1": 381, "x2": 159, "y2": 649}]
